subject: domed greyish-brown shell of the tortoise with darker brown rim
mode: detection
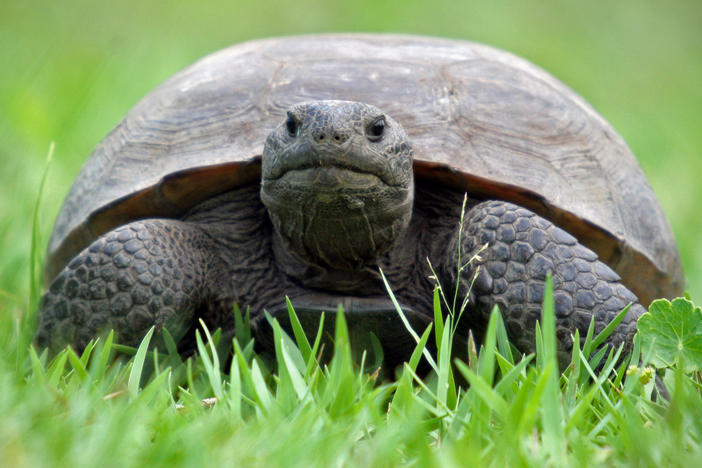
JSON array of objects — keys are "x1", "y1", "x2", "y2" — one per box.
[{"x1": 46, "y1": 35, "x2": 682, "y2": 304}]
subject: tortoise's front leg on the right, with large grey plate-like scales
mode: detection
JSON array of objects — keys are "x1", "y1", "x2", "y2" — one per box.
[{"x1": 443, "y1": 201, "x2": 645, "y2": 367}]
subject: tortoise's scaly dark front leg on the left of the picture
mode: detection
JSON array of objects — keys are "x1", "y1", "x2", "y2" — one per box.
[{"x1": 36, "y1": 219, "x2": 228, "y2": 352}]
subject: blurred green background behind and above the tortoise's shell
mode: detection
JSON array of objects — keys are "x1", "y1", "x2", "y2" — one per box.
[{"x1": 0, "y1": 0, "x2": 702, "y2": 311}]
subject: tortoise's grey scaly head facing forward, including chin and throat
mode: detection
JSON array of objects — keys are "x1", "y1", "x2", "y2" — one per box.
[{"x1": 261, "y1": 101, "x2": 414, "y2": 286}]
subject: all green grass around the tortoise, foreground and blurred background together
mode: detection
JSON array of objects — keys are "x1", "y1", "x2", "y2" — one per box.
[{"x1": 0, "y1": 0, "x2": 702, "y2": 466}]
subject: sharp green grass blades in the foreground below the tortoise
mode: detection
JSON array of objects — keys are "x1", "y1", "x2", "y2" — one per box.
[{"x1": 0, "y1": 266, "x2": 702, "y2": 467}]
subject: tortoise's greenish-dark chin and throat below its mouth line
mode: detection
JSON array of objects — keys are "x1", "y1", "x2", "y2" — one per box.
[{"x1": 261, "y1": 179, "x2": 414, "y2": 276}]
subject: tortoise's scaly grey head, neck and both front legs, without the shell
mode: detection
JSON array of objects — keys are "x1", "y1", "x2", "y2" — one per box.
[{"x1": 37, "y1": 101, "x2": 644, "y2": 365}]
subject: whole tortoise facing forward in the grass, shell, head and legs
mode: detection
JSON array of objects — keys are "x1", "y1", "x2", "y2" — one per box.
[{"x1": 37, "y1": 35, "x2": 682, "y2": 368}]
